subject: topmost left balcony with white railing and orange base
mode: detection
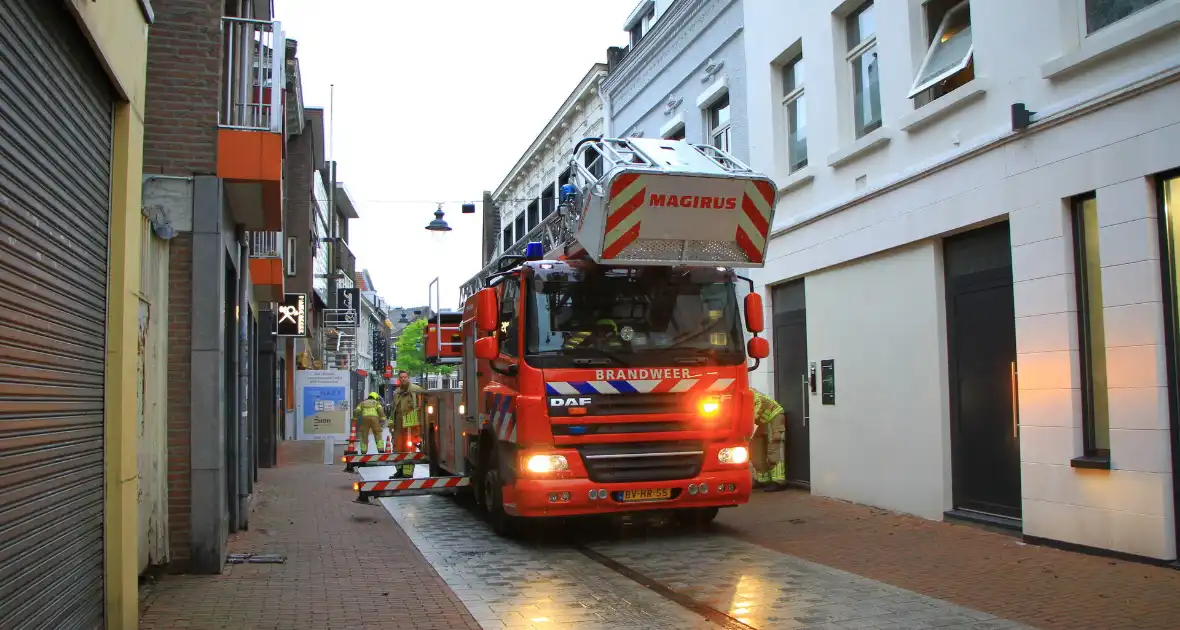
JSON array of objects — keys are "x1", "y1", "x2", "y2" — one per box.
[{"x1": 217, "y1": 18, "x2": 287, "y2": 231}]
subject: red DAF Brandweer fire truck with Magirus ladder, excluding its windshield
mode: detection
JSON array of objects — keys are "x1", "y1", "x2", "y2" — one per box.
[{"x1": 354, "y1": 137, "x2": 778, "y2": 533}]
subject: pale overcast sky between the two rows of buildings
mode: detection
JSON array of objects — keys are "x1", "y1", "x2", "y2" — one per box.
[{"x1": 275, "y1": 0, "x2": 637, "y2": 308}]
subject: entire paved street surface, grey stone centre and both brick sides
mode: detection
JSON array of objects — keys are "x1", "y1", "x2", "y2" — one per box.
[{"x1": 133, "y1": 442, "x2": 1180, "y2": 630}]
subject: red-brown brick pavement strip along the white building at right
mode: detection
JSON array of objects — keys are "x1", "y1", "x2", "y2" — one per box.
[{"x1": 717, "y1": 492, "x2": 1180, "y2": 630}]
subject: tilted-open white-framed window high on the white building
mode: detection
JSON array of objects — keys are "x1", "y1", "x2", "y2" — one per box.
[{"x1": 909, "y1": 0, "x2": 975, "y2": 101}]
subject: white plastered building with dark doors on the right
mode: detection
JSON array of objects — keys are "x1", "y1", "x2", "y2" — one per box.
[{"x1": 743, "y1": 0, "x2": 1180, "y2": 560}]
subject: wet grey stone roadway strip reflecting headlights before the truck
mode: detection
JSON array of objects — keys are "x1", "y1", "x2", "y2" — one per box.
[{"x1": 360, "y1": 467, "x2": 1025, "y2": 630}]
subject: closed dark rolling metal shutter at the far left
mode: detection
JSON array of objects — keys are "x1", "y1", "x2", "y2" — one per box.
[{"x1": 0, "y1": 0, "x2": 114, "y2": 630}]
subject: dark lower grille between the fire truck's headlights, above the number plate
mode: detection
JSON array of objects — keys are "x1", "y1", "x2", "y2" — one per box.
[{"x1": 577, "y1": 440, "x2": 704, "y2": 484}]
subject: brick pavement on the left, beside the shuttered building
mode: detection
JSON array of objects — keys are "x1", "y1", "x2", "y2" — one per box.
[{"x1": 140, "y1": 442, "x2": 479, "y2": 630}]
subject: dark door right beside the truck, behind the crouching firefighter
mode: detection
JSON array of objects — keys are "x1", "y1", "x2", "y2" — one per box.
[{"x1": 771, "y1": 278, "x2": 811, "y2": 485}]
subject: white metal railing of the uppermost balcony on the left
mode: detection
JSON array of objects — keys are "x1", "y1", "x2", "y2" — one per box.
[{"x1": 218, "y1": 18, "x2": 287, "y2": 133}]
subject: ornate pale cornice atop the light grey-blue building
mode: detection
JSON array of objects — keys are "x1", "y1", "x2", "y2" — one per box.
[{"x1": 602, "y1": 0, "x2": 736, "y2": 112}]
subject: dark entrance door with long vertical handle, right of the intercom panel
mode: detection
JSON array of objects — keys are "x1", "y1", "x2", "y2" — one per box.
[{"x1": 944, "y1": 222, "x2": 1021, "y2": 518}]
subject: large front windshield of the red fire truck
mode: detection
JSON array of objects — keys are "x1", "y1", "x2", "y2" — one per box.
[{"x1": 527, "y1": 267, "x2": 745, "y2": 367}]
